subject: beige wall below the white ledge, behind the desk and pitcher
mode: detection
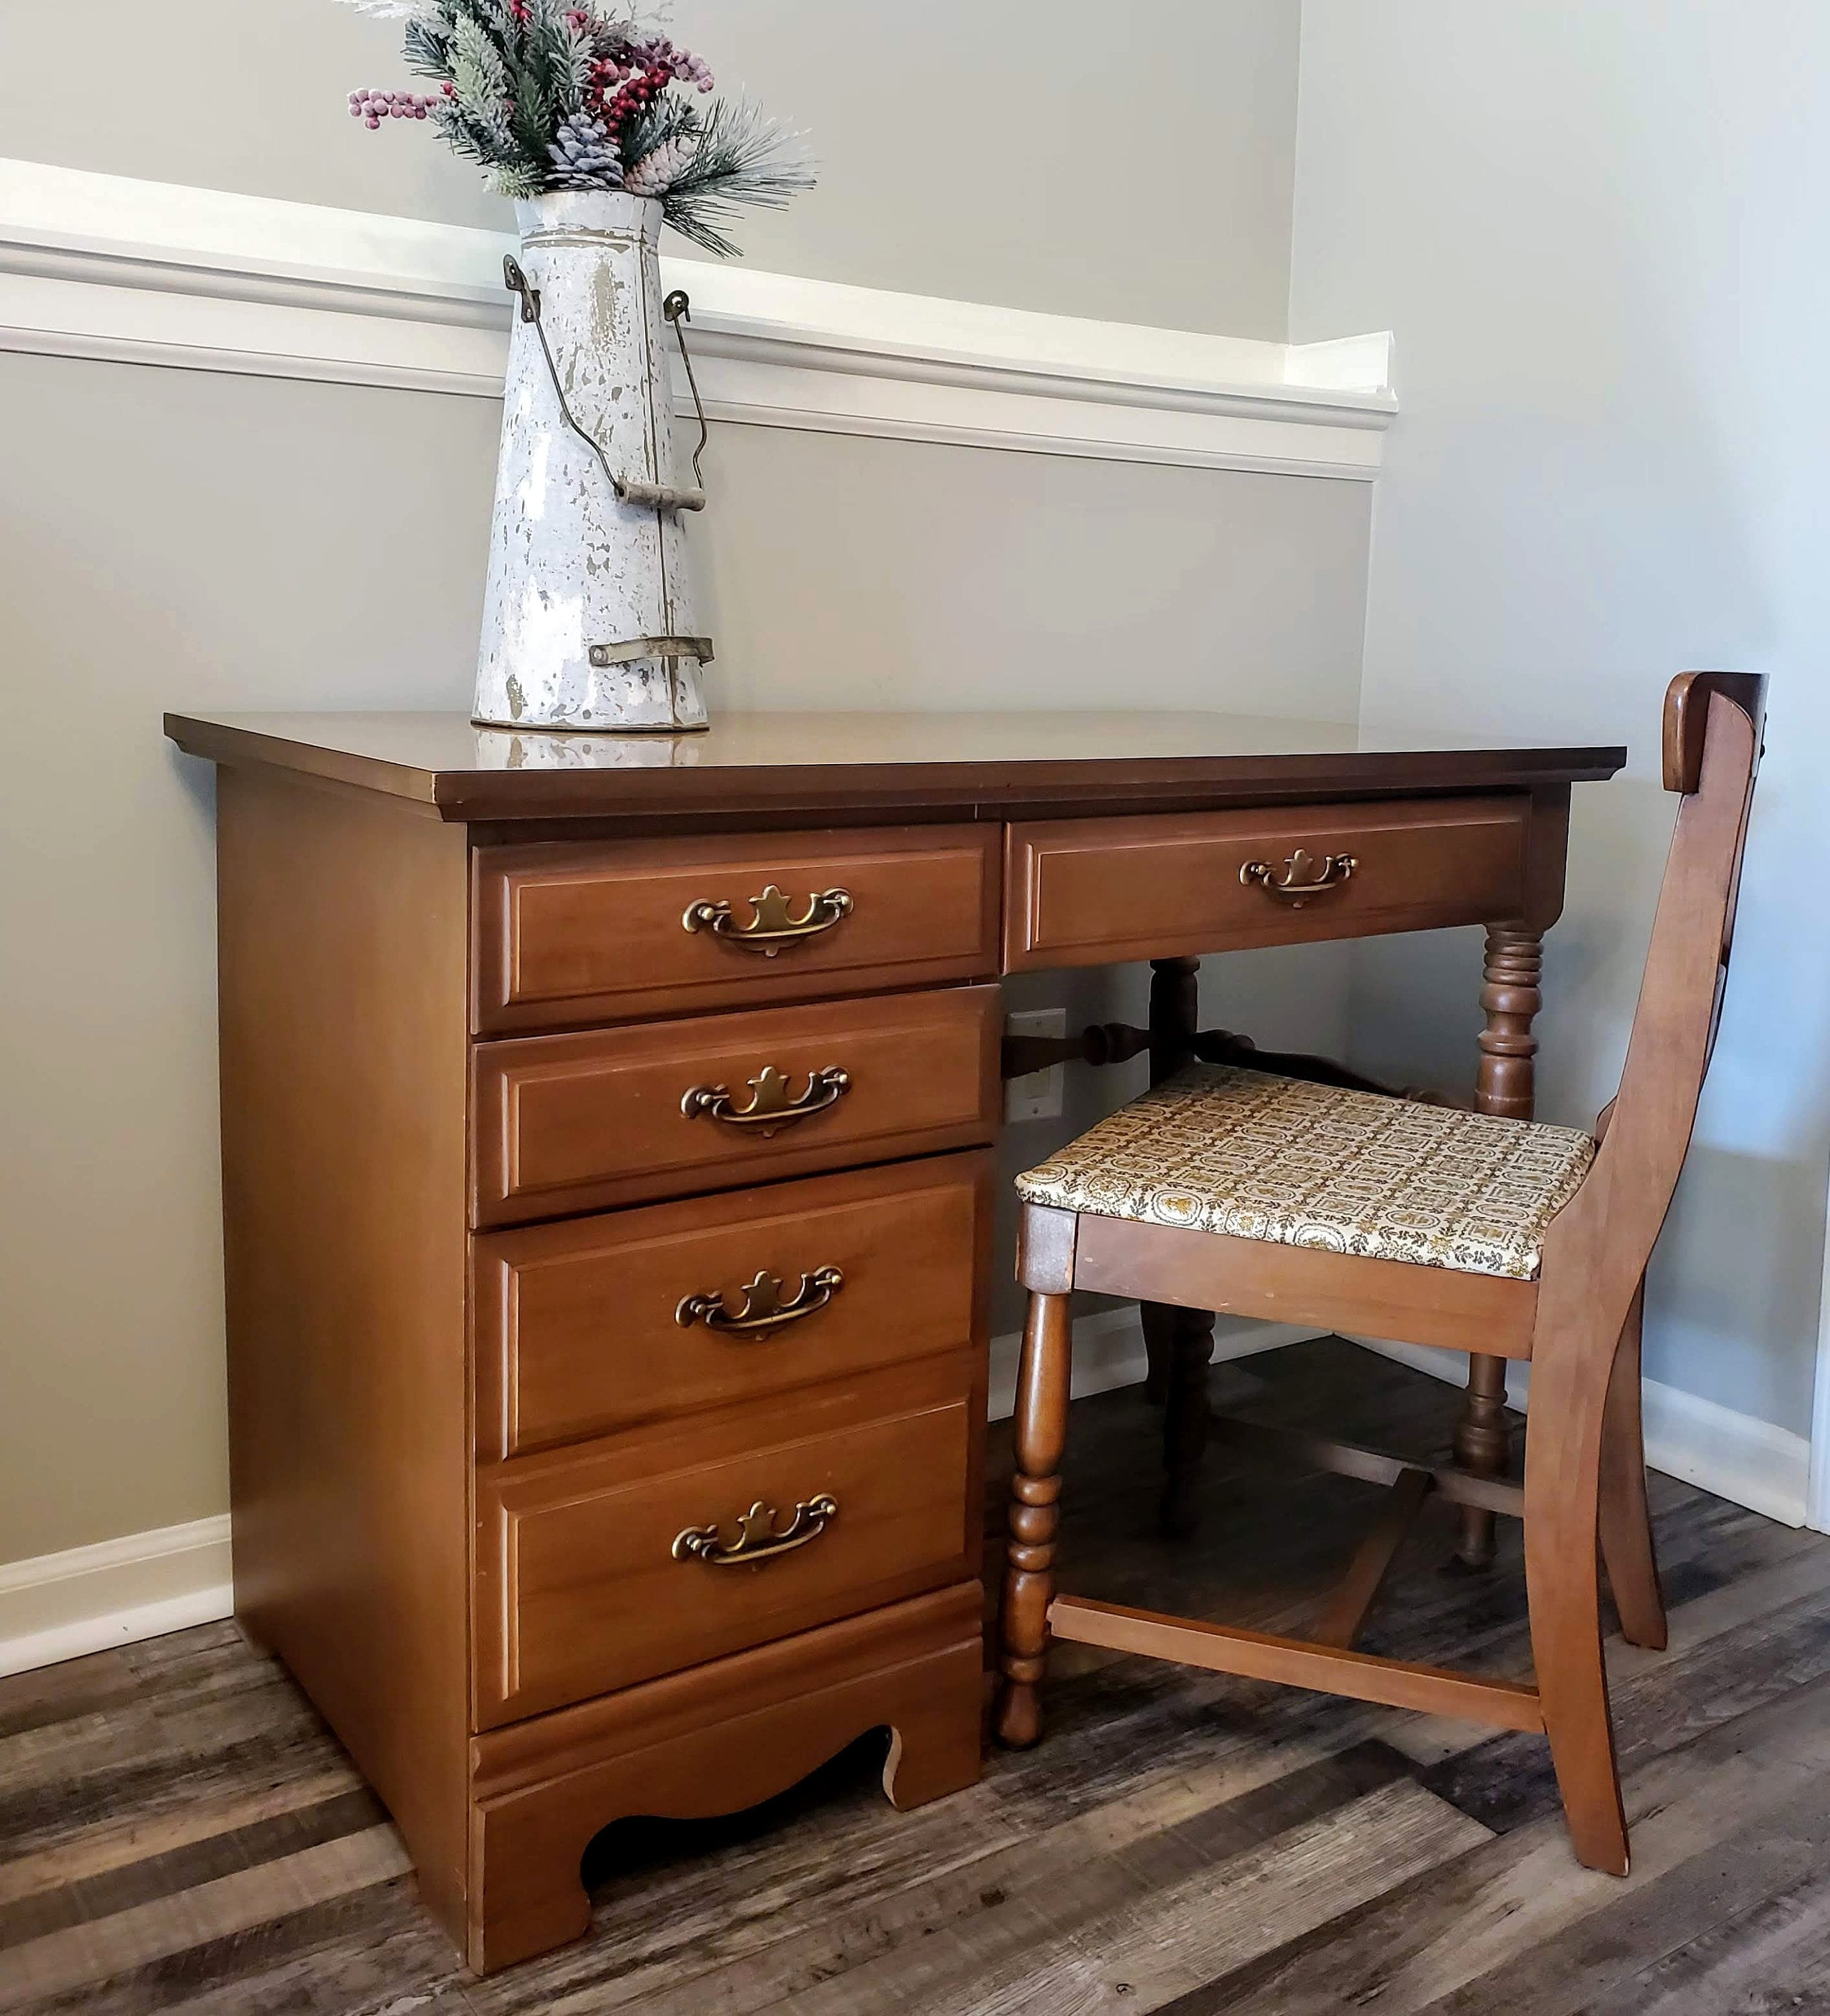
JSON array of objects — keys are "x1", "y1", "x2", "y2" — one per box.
[{"x1": 0, "y1": 339, "x2": 1368, "y2": 1562}]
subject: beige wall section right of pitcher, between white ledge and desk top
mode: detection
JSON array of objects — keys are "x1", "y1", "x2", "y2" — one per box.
[{"x1": 694, "y1": 427, "x2": 1370, "y2": 720}]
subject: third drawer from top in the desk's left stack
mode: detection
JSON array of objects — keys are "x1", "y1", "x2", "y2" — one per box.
[{"x1": 474, "y1": 1153, "x2": 991, "y2": 1458}]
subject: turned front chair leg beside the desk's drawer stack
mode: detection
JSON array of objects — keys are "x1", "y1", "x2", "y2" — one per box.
[{"x1": 995, "y1": 1294, "x2": 1074, "y2": 1750}]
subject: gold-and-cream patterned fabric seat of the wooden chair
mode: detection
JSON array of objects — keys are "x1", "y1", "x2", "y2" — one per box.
[{"x1": 1015, "y1": 1064, "x2": 1594, "y2": 1280}]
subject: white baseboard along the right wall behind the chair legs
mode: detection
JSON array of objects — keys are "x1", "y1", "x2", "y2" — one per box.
[{"x1": 1354, "y1": 1337, "x2": 1812, "y2": 1526}]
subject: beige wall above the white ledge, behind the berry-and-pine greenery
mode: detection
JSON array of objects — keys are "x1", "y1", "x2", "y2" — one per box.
[{"x1": 0, "y1": 0, "x2": 1314, "y2": 337}]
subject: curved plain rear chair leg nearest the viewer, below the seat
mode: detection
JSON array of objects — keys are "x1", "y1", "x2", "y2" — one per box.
[{"x1": 1526, "y1": 1353, "x2": 1626, "y2": 1877}]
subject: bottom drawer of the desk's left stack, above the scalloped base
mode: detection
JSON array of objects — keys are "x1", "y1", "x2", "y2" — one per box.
[{"x1": 476, "y1": 1353, "x2": 983, "y2": 1728}]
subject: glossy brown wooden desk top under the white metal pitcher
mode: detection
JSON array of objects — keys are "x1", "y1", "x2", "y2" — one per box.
[{"x1": 165, "y1": 712, "x2": 1626, "y2": 821}]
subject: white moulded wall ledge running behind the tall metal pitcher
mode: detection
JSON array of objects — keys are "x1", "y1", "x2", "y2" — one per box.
[{"x1": 0, "y1": 159, "x2": 1397, "y2": 482}]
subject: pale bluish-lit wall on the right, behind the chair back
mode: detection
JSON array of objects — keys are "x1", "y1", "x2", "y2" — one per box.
[{"x1": 1292, "y1": 0, "x2": 1830, "y2": 1452}]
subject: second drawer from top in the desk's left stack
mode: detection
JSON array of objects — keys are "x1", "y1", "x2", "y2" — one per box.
[{"x1": 472, "y1": 986, "x2": 999, "y2": 1226}]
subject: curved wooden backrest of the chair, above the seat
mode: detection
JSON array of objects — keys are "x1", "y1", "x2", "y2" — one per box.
[{"x1": 1544, "y1": 671, "x2": 1765, "y2": 1329}]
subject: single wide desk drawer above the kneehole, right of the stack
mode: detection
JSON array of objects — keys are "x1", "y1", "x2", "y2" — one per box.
[{"x1": 1003, "y1": 794, "x2": 1532, "y2": 972}]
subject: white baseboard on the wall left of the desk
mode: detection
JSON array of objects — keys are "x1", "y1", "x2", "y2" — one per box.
[{"x1": 0, "y1": 1512, "x2": 236, "y2": 1675}]
